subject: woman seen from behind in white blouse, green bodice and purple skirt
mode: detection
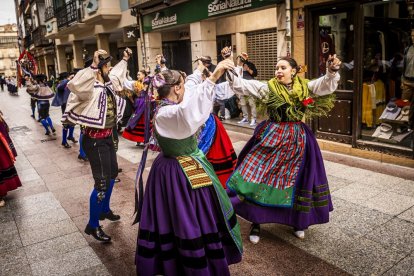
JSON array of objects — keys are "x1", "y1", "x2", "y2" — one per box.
[{"x1": 136, "y1": 57, "x2": 242, "y2": 276}]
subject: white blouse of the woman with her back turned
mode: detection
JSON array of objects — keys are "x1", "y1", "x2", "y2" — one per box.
[{"x1": 154, "y1": 70, "x2": 215, "y2": 139}]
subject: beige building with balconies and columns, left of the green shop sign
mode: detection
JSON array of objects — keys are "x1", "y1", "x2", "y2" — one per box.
[{"x1": 45, "y1": 0, "x2": 138, "y2": 76}]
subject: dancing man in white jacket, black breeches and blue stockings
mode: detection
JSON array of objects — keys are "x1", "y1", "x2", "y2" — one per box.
[{"x1": 62, "y1": 48, "x2": 132, "y2": 242}]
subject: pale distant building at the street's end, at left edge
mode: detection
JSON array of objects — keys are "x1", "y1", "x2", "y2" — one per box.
[{"x1": 0, "y1": 24, "x2": 19, "y2": 77}]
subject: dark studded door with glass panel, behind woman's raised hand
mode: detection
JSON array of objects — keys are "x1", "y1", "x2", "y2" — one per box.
[{"x1": 307, "y1": 6, "x2": 355, "y2": 143}]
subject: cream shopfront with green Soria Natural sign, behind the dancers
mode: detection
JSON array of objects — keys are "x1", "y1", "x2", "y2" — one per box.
[{"x1": 130, "y1": 0, "x2": 286, "y2": 77}]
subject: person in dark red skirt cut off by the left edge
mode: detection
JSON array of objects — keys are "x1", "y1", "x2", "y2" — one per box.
[{"x1": 0, "y1": 111, "x2": 22, "y2": 207}]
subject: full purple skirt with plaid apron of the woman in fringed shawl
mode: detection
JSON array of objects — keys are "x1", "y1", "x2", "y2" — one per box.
[{"x1": 227, "y1": 121, "x2": 333, "y2": 230}]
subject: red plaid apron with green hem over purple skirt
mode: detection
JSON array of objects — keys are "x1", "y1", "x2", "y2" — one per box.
[{"x1": 227, "y1": 122, "x2": 306, "y2": 207}]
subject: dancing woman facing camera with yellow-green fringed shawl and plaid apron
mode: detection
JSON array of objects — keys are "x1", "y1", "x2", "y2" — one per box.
[{"x1": 227, "y1": 52, "x2": 341, "y2": 243}]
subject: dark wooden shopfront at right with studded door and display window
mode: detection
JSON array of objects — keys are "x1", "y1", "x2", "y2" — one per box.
[{"x1": 292, "y1": 0, "x2": 414, "y2": 161}]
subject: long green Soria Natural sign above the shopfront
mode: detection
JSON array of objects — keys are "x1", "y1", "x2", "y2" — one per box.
[{"x1": 143, "y1": 0, "x2": 283, "y2": 32}]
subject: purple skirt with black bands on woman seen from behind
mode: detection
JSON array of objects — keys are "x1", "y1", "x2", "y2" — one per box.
[{"x1": 135, "y1": 153, "x2": 241, "y2": 276}]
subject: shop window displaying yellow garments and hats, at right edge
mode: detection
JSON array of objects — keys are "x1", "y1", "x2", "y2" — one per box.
[{"x1": 361, "y1": 0, "x2": 414, "y2": 148}]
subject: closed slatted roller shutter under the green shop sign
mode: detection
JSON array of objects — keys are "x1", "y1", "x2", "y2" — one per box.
[{"x1": 246, "y1": 28, "x2": 277, "y2": 80}]
